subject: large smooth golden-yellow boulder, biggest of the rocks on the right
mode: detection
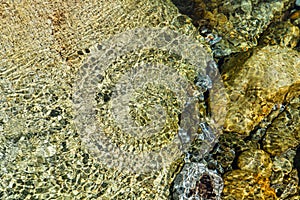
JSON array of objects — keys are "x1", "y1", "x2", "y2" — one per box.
[{"x1": 223, "y1": 46, "x2": 300, "y2": 136}]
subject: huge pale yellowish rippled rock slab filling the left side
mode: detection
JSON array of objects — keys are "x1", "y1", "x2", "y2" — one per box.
[{"x1": 0, "y1": 0, "x2": 224, "y2": 199}]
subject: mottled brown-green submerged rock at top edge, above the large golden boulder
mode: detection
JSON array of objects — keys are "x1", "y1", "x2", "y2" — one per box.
[{"x1": 181, "y1": 0, "x2": 294, "y2": 57}]
